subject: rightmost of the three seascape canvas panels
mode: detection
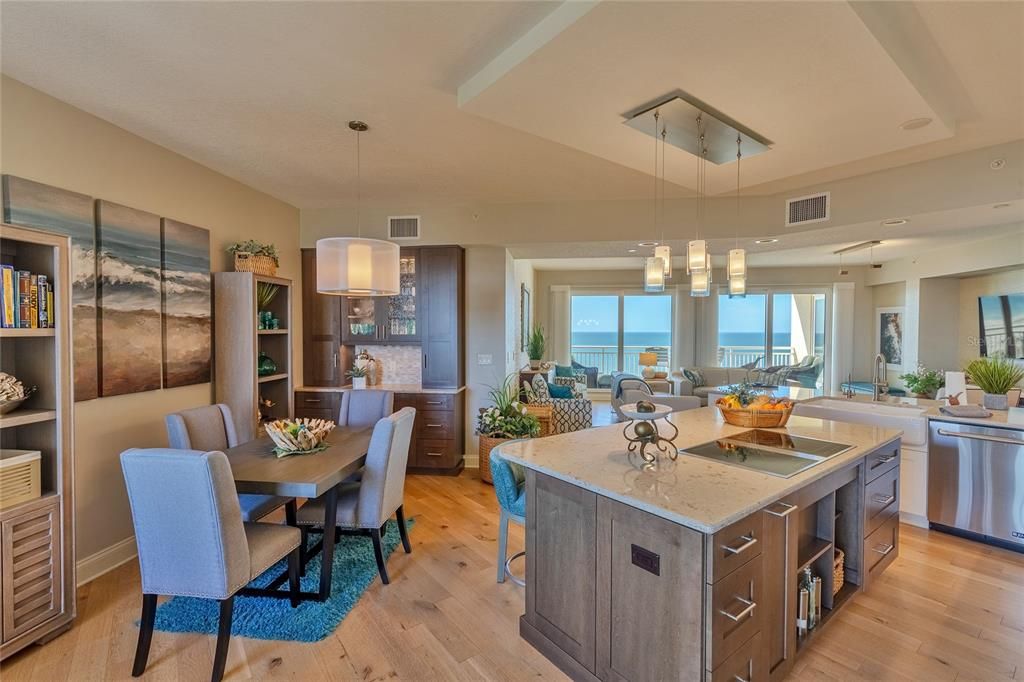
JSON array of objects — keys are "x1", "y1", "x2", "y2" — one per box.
[{"x1": 161, "y1": 218, "x2": 211, "y2": 388}]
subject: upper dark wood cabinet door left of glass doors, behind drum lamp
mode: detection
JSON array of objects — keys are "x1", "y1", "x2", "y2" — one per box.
[{"x1": 302, "y1": 249, "x2": 343, "y2": 386}]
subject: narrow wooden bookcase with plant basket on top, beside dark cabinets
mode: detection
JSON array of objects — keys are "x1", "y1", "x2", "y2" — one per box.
[{"x1": 213, "y1": 272, "x2": 294, "y2": 441}]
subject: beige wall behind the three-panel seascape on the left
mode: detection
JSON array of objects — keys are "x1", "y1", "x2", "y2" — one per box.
[{"x1": 0, "y1": 77, "x2": 302, "y2": 560}]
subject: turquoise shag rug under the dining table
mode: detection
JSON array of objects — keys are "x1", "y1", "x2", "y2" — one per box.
[{"x1": 149, "y1": 519, "x2": 414, "y2": 642}]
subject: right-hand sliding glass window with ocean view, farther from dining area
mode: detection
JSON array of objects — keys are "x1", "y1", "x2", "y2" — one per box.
[{"x1": 718, "y1": 290, "x2": 826, "y2": 388}]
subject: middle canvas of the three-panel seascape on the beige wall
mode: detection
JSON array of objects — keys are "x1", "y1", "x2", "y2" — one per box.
[{"x1": 96, "y1": 201, "x2": 163, "y2": 397}]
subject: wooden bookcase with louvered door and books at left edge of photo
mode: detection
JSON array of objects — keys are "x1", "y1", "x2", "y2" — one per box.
[{"x1": 0, "y1": 224, "x2": 76, "y2": 659}]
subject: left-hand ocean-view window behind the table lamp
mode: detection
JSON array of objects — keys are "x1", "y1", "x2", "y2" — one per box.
[{"x1": 570, "y1": 292, "x2": 673, "y2": 375}]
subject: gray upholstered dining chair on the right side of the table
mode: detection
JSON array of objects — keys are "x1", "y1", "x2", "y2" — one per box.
[{"x1": 298, "y1": 408, "x2": 416, "y2": 585}]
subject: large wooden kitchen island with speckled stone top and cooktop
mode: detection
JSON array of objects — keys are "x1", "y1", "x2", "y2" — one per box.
[{"x1": 501, "y1": 408, "x2": 900, "y2": 681}]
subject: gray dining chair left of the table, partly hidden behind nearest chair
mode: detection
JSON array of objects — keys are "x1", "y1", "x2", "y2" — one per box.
[{"x1": 164, "y1": 403, "x2": 296, "y2": 525}]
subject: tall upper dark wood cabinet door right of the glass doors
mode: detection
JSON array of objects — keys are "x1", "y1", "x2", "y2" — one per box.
[{"x1": 419, "y1": 247, "x2": 465, "y2": 388}]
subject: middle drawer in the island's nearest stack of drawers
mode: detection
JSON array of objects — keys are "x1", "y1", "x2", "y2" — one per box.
[{"x1": 705, "y1": 556, "x2": 764, "y2": 670}]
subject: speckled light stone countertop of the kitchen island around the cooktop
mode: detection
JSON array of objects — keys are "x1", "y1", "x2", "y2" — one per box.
[{"x1": 501, "y1": 408, "x2": 901, "y2": 532}]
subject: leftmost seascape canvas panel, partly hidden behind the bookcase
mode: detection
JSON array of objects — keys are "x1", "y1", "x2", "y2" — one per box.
[{"x1": 3, "y1": 175, "x2": 99, "y2": 400}]
